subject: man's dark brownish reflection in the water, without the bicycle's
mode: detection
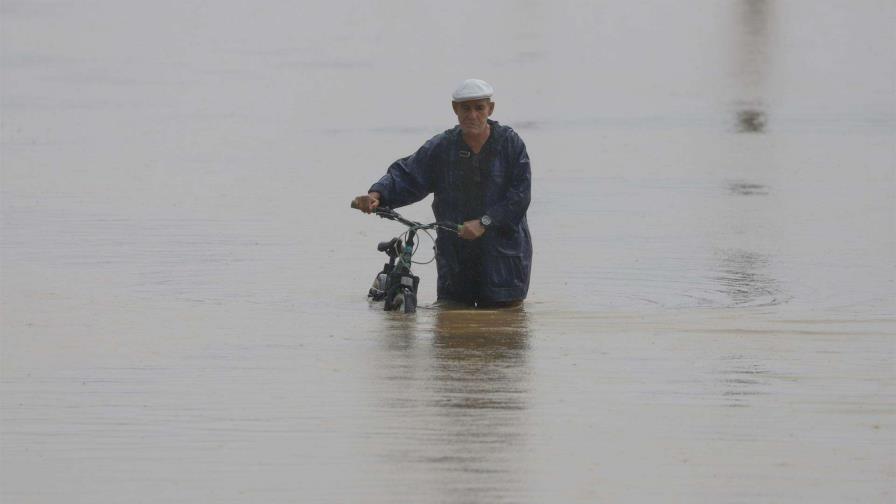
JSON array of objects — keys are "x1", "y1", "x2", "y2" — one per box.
[{"x1": 424, "y1": 308, "x2": 530, "y2": 496}]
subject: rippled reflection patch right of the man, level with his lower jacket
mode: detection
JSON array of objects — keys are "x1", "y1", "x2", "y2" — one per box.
[{"x1": 715, "y1": 249, "x2": 782, "y2": 307}]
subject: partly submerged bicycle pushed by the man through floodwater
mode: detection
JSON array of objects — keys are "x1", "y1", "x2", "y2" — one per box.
[{"x1": 351, "y1": 201, "x2": 459, "y2": 313}]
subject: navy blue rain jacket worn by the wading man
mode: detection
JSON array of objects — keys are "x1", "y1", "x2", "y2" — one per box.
[{"x1": 370, "y1": 120, "x2": 532, "y2": 302}]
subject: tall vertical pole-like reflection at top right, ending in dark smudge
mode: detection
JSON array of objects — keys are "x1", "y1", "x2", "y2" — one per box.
[{"x1": 735, "y1": 0, "x2": 770, "y2": 133}]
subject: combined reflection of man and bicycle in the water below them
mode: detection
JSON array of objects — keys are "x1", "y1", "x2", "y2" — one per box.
[{"x1": 372, "y1": 307, "x2": 530, "y2": 502}]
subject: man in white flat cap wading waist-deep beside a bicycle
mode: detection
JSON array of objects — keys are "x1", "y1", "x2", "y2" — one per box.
[{"x1": 355, "y1": 79, "x2": 532, "y2": 307}]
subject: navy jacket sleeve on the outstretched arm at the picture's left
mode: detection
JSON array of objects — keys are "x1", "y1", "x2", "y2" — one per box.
[{"x1": 370, "y1": 135, "x2": 439, "y2": 208}]
